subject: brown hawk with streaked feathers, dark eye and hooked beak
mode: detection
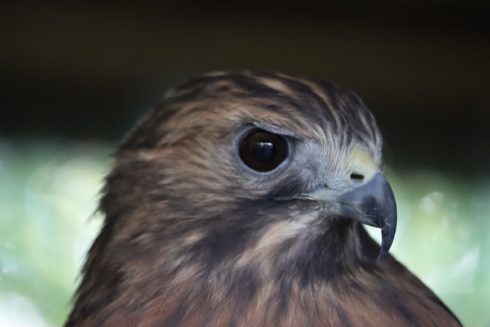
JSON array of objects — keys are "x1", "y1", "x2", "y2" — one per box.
[{"x1": 66, "y1": 72, "x2": 460, "y2": 326}]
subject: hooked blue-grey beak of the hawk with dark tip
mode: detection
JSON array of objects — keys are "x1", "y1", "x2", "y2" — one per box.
[{"x1": 337, "y1": 172, "x2": 397, "y2": 260}]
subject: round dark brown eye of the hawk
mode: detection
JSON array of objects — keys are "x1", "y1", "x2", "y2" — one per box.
[{"x1": 239, "y1": 129, "x2": 288, "y2": 172}]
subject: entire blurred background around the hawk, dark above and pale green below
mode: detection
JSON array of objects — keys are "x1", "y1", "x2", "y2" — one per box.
[{"x1": 0, "y1": 0, "x2": 490, "y2": 326}]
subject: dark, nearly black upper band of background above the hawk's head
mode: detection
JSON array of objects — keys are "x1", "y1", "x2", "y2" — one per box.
[{"x1": 0, "y1": 0, "x2": 490, "y2": 176}]
